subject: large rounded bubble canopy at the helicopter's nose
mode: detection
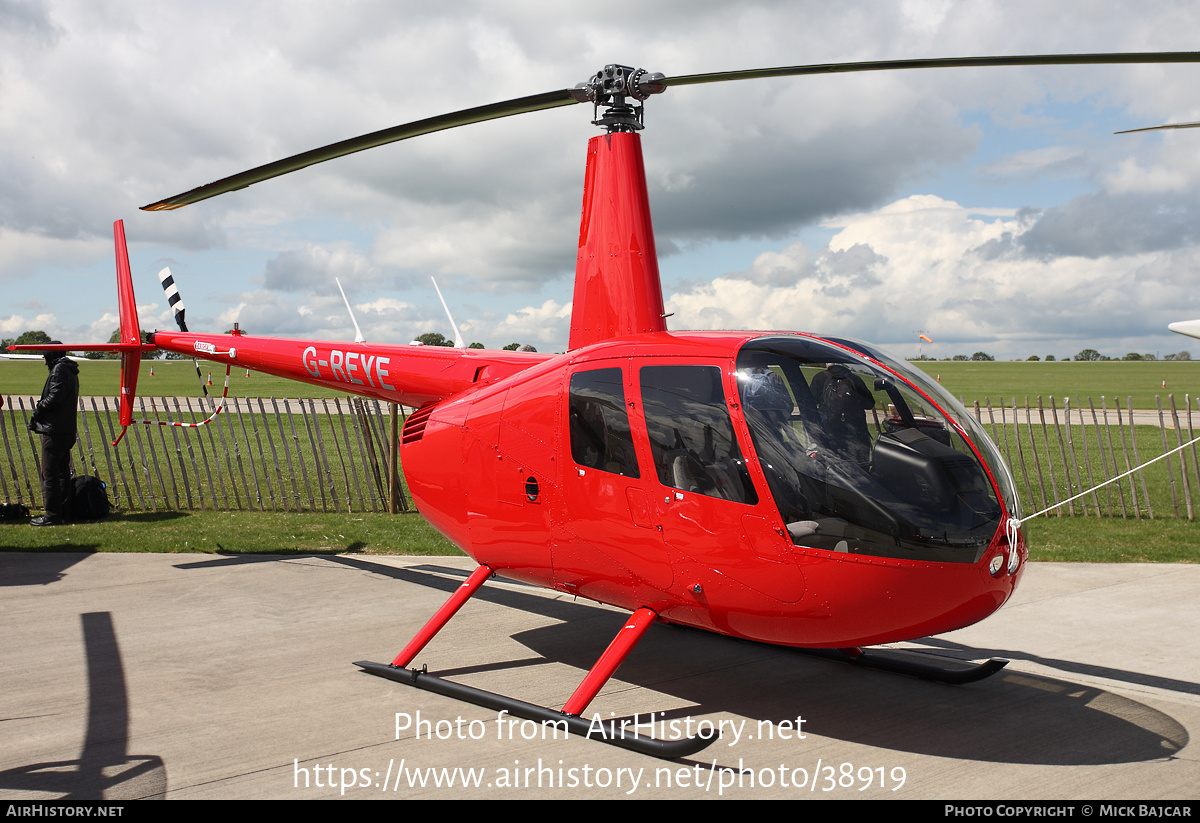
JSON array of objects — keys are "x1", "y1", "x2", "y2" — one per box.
[{"x1": 737, "y1": 335, "x2": 1020, "y2": 563}]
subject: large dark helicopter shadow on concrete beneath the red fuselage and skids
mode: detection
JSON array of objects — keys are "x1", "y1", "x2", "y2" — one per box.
[{"x1": 337, "y1": 558, "x2": 1195, "y2": 765}]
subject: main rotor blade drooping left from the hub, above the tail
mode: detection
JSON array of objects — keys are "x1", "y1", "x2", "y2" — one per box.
[{"x1": 142, "y1": 89, "x2": 580, "y2": 211}]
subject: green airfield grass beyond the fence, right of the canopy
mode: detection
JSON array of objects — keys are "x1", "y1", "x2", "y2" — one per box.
[{"x1": 912, "y1": 360, "x2": 1200, "y2": 409}]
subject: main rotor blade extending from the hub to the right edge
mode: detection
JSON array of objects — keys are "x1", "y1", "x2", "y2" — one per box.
[{"x1": 660, "y1": 52, "x2": 1200, "y2": 86}]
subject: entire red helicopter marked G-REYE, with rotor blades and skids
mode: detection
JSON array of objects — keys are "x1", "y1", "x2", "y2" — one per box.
[{"x1": 20, "y1": 53, "x2": 1200, "y2": 757}]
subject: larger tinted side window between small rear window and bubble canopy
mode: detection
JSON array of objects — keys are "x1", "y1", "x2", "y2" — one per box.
[{"x1": 641, "y1": 366, "x2": 758, "y2": 505}]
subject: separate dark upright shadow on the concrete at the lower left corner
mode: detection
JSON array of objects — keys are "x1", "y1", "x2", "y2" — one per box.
[{"x1": 0, "y1": 612, "x2": 167, "y2": 800}]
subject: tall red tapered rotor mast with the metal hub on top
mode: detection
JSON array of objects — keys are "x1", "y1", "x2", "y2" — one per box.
[{"x1": 568, "y1": 65, "x2": 666, "y2": 350}]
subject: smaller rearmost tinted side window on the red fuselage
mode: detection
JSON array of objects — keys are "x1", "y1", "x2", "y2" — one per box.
[{"x1": 569, "y1": 368, "x2": 640, "y2": 477}]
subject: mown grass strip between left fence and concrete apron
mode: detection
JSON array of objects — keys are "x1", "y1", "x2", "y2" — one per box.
[{"x1": 0, "y1": 511, "x2": 462, "y2": 555}]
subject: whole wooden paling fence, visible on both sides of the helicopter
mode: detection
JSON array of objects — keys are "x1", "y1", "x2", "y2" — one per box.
[{"x1": 7, "y1": 395, "x2": 1200, "y2": 519}]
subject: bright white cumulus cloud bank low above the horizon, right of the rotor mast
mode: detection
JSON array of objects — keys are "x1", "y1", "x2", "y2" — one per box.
[{"x1": 667, "y1": 196, "x2": 1200, "y2": 356}]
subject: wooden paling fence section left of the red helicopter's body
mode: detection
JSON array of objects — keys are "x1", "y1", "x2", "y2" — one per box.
[{"x1": 0, "y1": 397, "x2": 408, "y2": 512}]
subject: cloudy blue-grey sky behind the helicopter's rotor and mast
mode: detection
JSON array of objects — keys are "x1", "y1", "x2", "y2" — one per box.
[{"x1": 0, "y1": 0, "x2": 1200, "y2": 359}]
